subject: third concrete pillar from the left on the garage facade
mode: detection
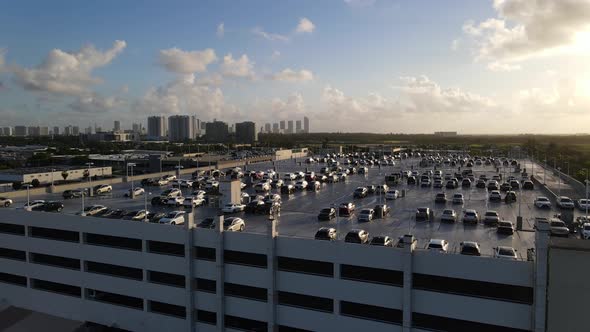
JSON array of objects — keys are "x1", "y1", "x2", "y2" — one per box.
[{"x1": 266, "y1": 219, "x2": 279, "y2": 332}]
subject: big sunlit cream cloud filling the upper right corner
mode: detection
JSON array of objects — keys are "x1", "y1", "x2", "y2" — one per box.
[{"x1": 463, "y1": 0, "x2": 590, "y2": 66}]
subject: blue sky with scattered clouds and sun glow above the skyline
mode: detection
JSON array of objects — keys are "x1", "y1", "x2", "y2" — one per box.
[{"x1": 0, "y1": 0, "x2": 590, "y2": 134}]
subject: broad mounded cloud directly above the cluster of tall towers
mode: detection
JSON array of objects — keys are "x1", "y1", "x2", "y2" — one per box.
[{"x1": 132, "y1": 74, "x2": 236, "y2": 119}]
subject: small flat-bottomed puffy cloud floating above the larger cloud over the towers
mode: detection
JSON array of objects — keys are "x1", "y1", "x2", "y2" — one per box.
[{"x1": 159, "y1": 48, "x2": 217, "y2": 74}]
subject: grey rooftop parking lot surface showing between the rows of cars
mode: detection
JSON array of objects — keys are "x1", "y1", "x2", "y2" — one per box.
[{"x1": 9, "y1": 154, "x2": 577, "y2": 257}]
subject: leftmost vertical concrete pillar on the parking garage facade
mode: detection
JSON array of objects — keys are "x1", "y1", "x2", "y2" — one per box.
[{"x1": 184, "y1": 212, "x2": 196, "y2": 332}]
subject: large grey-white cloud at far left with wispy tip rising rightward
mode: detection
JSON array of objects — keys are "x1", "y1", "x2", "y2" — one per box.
[{"x1": 12, "y1": 40, "x2": 127, "y2": 96}]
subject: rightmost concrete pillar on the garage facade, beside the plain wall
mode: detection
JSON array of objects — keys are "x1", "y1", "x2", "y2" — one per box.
[{"x1": 533, "y1": 219, "x2": 551, "y2": 332}]
